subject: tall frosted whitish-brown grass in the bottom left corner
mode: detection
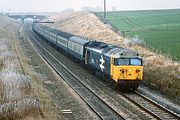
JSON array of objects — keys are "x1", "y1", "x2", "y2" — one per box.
[{"x1": 0, "y1": 43, "x2": 40, "y2": 120}]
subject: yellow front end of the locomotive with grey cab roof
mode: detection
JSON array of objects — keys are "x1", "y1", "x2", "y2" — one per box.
[{"x1": 110, "y1": 50, "x2": 143, "y2": 90}]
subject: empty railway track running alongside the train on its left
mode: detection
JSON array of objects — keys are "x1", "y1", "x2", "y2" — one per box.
[{"x1": 22, "y1": 23, "x2": 125, "y2": 120}]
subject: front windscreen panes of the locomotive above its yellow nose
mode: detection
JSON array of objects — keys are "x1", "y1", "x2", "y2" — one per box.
[{"x1": 114, "y1": 58, "x2": 142, "y2": 66}]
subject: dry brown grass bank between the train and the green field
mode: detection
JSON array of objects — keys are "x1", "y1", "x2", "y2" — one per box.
[{"x1": 49, "y1": 12, "x2": 180, "y2": 98}]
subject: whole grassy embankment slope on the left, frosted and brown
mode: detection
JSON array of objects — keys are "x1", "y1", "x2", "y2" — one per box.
[{"x1": 0, "y1": 16, "x2": 60, "y2": 120}]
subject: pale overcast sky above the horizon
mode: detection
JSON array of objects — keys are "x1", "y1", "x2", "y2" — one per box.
[{"x1": 0, "y1": 0, "x2": 180, "y2": 12}]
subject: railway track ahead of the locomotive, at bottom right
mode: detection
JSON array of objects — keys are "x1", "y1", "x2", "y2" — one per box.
[{"x1": 121, "y1": 91, "x2": 180, "y2": 120}]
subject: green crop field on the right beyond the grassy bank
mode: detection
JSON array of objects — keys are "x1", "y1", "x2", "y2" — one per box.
[{"x1": 98, "y1": 9, "x2": 180, "y2": 61}]
